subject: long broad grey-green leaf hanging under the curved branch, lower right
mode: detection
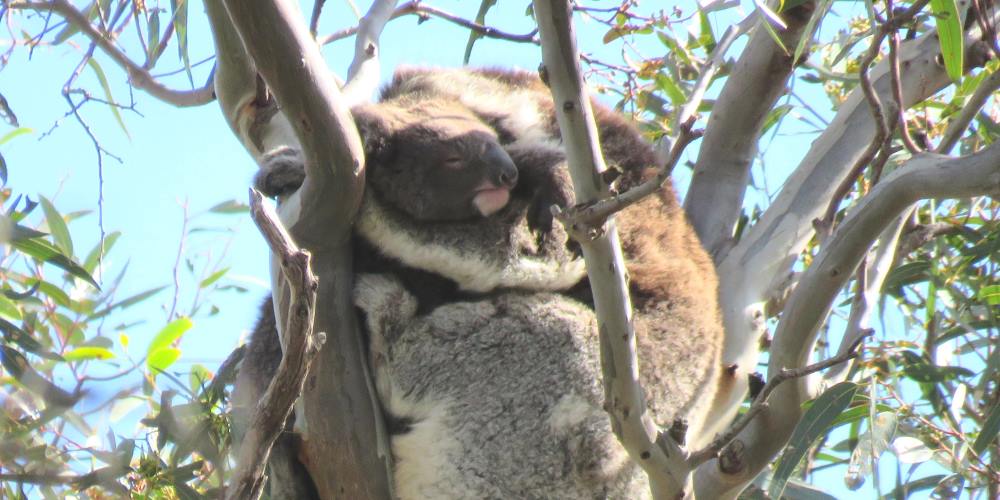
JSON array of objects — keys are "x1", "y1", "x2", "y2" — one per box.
[{"x1": 768, "y1": 382, "x2": 858, "y2": 498}]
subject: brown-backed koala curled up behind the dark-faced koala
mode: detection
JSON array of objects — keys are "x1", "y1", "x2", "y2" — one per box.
[{"x1": 382, "y1": 68, "x2": 726, "y2": 447}]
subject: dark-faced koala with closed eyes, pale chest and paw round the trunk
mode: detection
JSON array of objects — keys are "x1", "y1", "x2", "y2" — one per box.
[{"x1": 233, "y1": 88, "x2": 586, "y2": 498}]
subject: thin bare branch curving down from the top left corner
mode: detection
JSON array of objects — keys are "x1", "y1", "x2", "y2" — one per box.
[{"x1": 8, "y1": 0, "x2": 215, "y2": 107}]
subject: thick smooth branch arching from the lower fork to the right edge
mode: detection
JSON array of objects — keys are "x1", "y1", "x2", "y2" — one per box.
[{"x1": 695, "y1": 140, "x2": 1000, "y2": 498}]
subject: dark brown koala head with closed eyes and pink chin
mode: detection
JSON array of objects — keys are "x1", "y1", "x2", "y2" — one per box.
[{"x1": 352, "y1": 98, "x2": 518, "y2": 222}]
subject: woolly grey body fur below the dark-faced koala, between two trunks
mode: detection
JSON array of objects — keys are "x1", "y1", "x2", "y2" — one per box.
[{"x1": 355, "y1": 274, "x2": 649, "y2": 500}]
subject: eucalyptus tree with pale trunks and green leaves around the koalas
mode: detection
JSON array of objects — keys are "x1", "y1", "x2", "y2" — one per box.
[{"x1": 0, "y1": 0, "x2": 1000, "y2": 498}]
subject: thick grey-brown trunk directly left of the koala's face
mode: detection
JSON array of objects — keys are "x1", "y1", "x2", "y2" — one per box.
[{"x1": 215, "y1": 0, "x2": 390, "y2": 499}]
